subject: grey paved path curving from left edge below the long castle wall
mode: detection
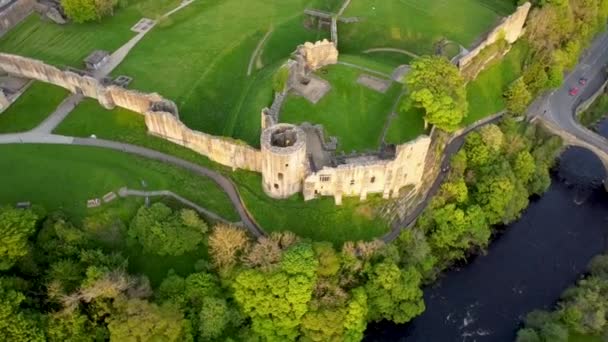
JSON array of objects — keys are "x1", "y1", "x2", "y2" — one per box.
[{"x1": 0, "y1": 133, "x2": 264, "y2": 237}]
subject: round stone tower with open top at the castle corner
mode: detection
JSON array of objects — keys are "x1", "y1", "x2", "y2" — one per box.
[{"x1": 261, "y1": 124, "x2": 308, "y2": 198}]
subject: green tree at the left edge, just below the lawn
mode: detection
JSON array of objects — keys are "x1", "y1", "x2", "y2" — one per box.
[{"x1": 0, "y1": 207, "x2": 38, "y2": 270}]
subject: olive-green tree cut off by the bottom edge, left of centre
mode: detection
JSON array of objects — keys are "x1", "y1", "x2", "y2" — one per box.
[{"x1": 108, "y1": 299, "x2": 191, "y2": 342}]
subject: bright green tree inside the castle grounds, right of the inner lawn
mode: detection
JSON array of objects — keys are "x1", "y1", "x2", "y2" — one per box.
[{"x1": 402, "y1": 56, "x2": 468, "y2": 132}]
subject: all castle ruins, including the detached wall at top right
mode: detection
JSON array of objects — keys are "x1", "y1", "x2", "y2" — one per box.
[{"x1": 0, "y1": 0, "x2": 530, "y2": 204}]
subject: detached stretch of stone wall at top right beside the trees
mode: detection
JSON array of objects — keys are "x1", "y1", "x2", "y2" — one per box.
[{"x1": 458, "y1": 2, "x2": 532, "y2": 69}]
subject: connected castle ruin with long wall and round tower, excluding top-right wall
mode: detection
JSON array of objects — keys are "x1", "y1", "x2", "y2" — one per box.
[{"x1": 0, "y1": 37, "x2": 430, "y2": 204}]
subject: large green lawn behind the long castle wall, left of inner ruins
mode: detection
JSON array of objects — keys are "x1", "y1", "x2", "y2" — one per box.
[{"x1": 115, "y1": 0, "x2": 323, "y2": 145}]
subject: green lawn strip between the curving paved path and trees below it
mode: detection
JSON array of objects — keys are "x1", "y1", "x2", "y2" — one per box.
[{"x1": 0, "y1": 145, "x2": 238, "y2": 221}]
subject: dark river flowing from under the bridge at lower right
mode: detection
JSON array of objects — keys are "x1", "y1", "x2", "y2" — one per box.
[{"x1": 366, "y1": 145, "x2": 608, "y2": 342}]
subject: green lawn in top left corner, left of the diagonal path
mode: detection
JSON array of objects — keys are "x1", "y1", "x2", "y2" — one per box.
[{"x1": 0, "y1": 0, "x2": 179, "y2": 68}]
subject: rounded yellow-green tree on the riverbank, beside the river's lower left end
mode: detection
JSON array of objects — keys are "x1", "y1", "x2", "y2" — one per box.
[{"x1": 365, "y1": 261, "x2": 425, "y2": 323}]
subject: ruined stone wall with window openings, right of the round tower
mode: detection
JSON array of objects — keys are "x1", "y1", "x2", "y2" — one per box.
[{"x1": 304, "y1": 136, "x2": 431, "y2": 204}]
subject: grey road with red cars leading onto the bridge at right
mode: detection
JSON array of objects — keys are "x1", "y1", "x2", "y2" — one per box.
[{"x1": 529, "y1": 33, "x2": 608, "y2": 160}]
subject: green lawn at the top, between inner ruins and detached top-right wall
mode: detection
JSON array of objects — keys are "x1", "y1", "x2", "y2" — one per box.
[{"x1": 338, "y1": 0, "x2": 514, "y2": 54}]
